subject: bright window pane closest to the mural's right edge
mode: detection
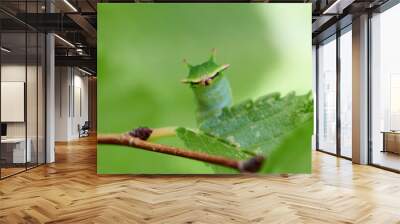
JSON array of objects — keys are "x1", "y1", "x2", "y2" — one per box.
[{"x1": 318, "y1": 39, "x2": 336, "y2": 153}]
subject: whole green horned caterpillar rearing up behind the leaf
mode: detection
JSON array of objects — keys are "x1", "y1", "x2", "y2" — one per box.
[{"x1": 182, "y1": 49, "x2": 232, "y2": 124}]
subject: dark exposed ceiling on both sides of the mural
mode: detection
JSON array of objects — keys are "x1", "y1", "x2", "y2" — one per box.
[{"x1": 0, "y1": 0, "x2": 394, "y2": 73}]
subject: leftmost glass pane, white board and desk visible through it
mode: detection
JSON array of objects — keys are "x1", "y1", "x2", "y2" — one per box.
[{"x1": 0, "y1": 32, "x2": 27, "y2": 177}]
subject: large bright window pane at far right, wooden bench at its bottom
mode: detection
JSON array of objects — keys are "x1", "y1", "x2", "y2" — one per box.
[{"x1": 371, "y1": 5, "x2": 400, "y2": 170}]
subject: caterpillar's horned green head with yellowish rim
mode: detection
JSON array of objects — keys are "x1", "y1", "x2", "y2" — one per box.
[{"x1": 182, "y1": 49, "x2": 229, "y2": 87}]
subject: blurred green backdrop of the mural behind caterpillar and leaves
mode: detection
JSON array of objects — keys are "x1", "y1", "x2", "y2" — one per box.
[{"x1": 97, "y1": 3, "x2": 312, "y2": 174}]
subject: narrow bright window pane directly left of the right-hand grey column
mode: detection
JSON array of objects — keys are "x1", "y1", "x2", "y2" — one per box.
[{"x1": 340, "y1": 30, "x2": 352, "y2": 158}]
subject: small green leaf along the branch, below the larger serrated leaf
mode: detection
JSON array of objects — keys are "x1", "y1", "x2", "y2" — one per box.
[{"x1": 176, "y1": 127, "x2": 252, "y2": 173}]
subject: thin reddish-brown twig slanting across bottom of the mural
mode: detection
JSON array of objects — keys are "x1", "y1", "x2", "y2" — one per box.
[{"x1": 97, "y1": 134, "x2": 264, "y2": 172}]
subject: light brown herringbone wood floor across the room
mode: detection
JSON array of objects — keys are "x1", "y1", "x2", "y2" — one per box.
[{"x1": 0, "y1": 138, "x2": 400, "y2": 224}]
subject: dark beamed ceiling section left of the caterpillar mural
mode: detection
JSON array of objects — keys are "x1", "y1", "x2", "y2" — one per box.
[{"x1": 0, "y1": 0, "x2": 97, "y2": 74}]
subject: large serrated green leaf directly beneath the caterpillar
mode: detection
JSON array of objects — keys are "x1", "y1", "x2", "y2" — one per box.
[{"x1": 200, "y1": 93, "x2": 313, "y2": 156}]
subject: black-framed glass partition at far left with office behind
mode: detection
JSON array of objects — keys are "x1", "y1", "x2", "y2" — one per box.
[{"x1": 0, "y1": 1, "x2": 46, "y2": 178}]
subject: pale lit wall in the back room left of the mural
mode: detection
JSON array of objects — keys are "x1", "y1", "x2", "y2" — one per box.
[{"x1": 55, "y1": 67, "x2": 88, "y2": 141}]
